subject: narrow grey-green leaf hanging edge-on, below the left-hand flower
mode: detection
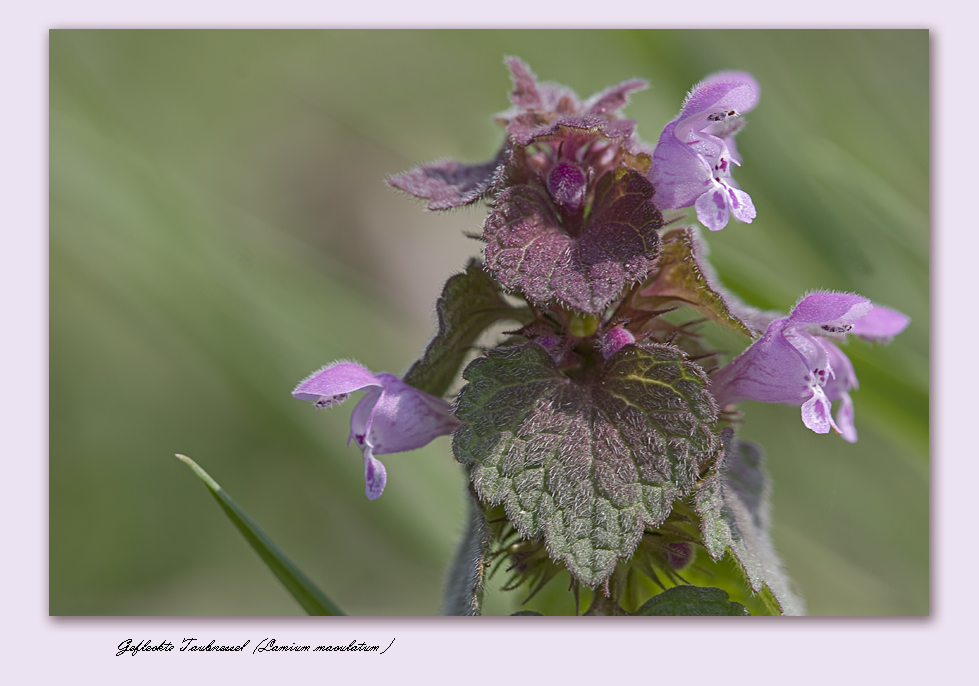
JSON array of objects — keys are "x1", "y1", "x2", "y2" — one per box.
[{"x1": 442, "y1": 495, "x2": 492, "y2": 616}]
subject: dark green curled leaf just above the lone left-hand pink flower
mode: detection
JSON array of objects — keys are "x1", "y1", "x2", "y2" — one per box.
[{"x1": 404, "y1": 259, "x2": 532, "y2": 397}]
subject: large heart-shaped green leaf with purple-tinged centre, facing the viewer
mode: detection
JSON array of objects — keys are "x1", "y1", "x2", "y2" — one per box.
[{"x1": 452, "y1": 343, "x2": 720, "y2": 587}]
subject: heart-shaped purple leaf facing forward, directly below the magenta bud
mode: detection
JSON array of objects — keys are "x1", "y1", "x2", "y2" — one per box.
[{"x1": 483, "y1": 167, "x2": 663, "y2": 314}]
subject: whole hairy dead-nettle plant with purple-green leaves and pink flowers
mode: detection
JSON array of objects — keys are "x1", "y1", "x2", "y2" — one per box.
[{"x1": 178, "y1": 57, "x2": 909, "y2": 615}]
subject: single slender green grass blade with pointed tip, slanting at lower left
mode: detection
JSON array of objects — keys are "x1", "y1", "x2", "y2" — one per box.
[{"x1": 177, "y1": 455, "x2": 344, "y2": 617}]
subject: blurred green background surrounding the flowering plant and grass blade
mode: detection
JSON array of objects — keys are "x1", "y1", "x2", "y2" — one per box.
[{"x1": 49, "y1": 31, "x2": 929, "y2": 615}]
